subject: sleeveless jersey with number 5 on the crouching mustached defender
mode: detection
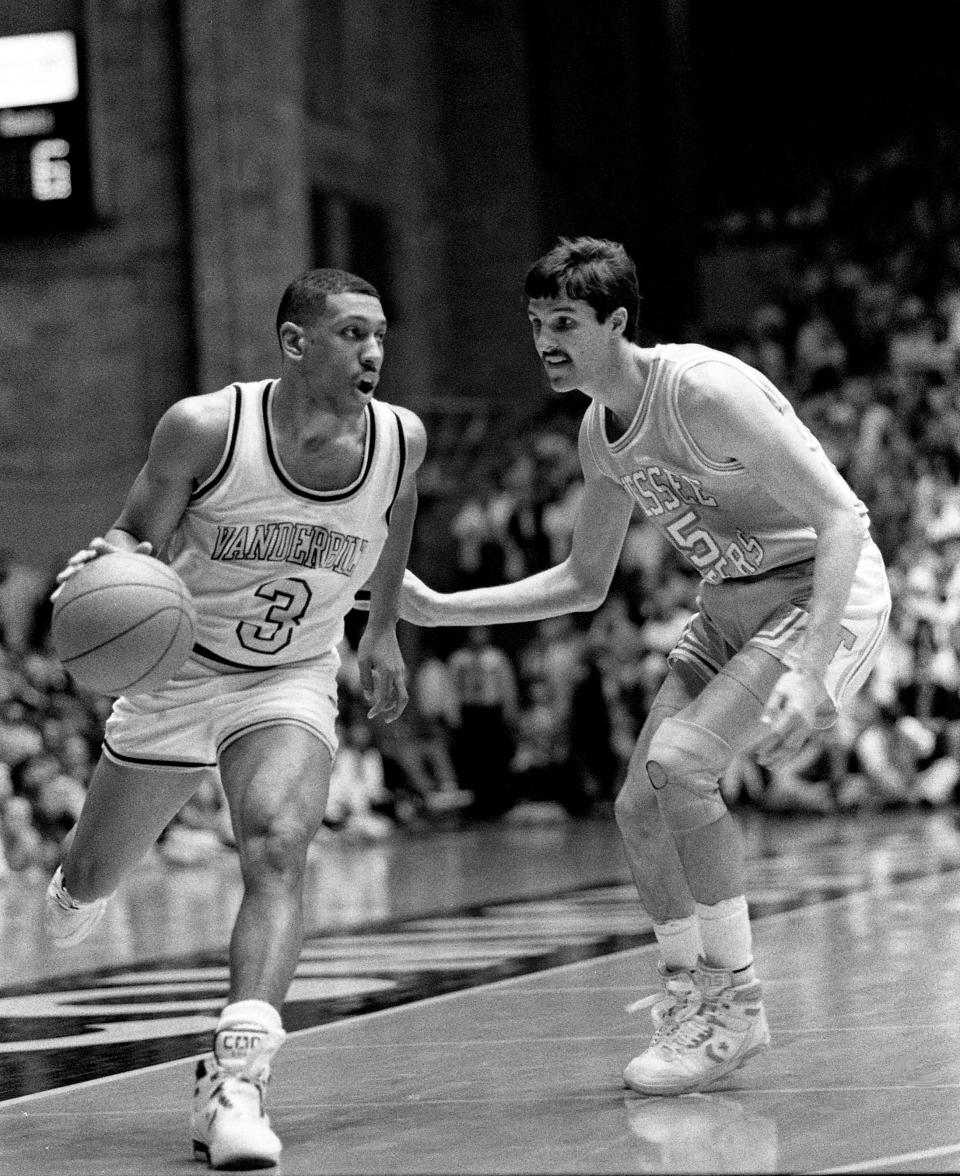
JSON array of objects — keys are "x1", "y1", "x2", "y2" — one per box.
[{"x1": 584, "y1": 343, "x2": 869, "y2": 583}]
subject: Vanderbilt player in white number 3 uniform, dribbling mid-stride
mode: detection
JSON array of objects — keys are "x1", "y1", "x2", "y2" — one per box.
[{"x1": 46, "y1": 269, "x2": 426, "y2": 1168}]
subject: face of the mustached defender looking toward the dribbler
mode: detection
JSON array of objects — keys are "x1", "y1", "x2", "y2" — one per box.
[{"x1": 527, "y1": 298, "x2": 612, "y2": 392}]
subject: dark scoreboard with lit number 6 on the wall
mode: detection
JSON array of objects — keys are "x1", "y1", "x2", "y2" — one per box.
[{"x1": 0, "y1": 31, "x2": 93, "y2": 236}]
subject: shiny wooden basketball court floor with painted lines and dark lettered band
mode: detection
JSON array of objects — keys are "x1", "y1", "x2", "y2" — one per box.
[{"x1": 0, "y1": 811, "x2": 960, "y2": 1176}]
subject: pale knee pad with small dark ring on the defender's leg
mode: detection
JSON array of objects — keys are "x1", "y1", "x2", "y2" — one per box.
[{"x1": 647, "y1": 719, "x2": 734, "y2": 833}]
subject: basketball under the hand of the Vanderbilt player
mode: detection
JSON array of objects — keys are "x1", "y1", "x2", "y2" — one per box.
[{"x1": 51, "y1": 552, "x2": 196, "y2": 695}]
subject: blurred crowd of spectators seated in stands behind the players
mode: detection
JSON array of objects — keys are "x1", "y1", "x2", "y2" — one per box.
[{"x1": 0, "y1": 128, "x2": 960, "y2": 877}]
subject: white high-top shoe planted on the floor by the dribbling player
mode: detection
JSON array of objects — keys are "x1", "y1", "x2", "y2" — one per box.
[{"x1": 191, "y1": 1024, "x2": 285, "y2": 1169}]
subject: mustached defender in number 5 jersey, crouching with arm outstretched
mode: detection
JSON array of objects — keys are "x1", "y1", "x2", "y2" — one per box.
[{"x1": 385, "y1": 238, "x2": 889, "y2": 1095}]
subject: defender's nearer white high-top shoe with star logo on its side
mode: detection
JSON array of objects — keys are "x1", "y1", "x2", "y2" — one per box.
[{"x1": 624, "y1": 961, "x2": 771, "y2": 1095}]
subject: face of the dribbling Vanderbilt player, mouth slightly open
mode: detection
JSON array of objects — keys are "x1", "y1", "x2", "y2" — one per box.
[{"x1": 287, "y1": 293, "x2": 387, "y2": 405}]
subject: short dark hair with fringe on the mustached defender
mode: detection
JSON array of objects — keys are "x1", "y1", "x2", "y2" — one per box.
[{"x1": 524, "y1": 236, "x2": 640, "y2": 340}]
